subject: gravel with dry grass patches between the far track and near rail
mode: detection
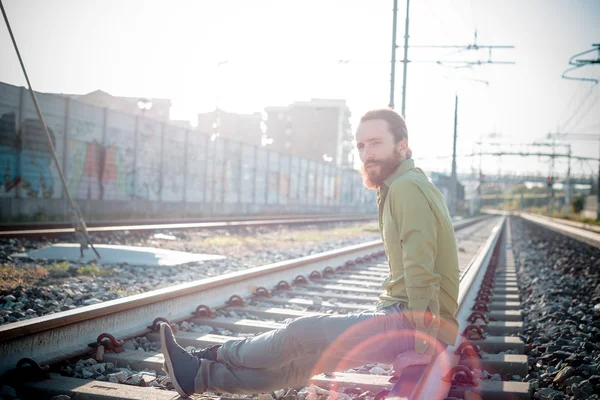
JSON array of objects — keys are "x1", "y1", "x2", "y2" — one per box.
[{"x1": 0, "y1": 222, "x2": 380, "y2": 330}]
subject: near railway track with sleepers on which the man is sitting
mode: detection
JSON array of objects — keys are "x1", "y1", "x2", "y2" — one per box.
[{"x1": 0, "y1": 216, "x2": 600, "y2": 400}]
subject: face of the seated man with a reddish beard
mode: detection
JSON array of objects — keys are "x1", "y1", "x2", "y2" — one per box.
[{"x1": 356, "y1": 119, "x2": 407, "y2": 190}]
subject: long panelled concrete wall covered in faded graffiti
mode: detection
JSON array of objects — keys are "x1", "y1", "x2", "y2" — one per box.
[{"x1": 0, "y1": 83, "x2": 374, "y2": 219}]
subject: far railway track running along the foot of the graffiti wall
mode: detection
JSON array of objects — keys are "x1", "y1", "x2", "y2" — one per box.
[{"x1": 0, "y1": 214, "x2": 376, "y2": 239}]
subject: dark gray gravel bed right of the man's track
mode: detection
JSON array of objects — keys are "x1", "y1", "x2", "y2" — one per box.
[{"x1": 510, "y1": 217, "x2": 600, "y2": 400}]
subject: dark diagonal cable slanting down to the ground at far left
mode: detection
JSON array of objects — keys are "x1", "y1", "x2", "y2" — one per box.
[{"x1": 0, "y1": 0, "x2": 101, "y2": 258}]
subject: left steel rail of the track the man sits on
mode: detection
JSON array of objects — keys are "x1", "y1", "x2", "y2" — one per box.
[{"x1": 0, "y1": 216, "x2": 487, "y2": 374}]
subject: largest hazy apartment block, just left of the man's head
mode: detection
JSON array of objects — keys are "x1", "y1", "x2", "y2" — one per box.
[{"x1": 265, "y1": 99, "x2": 354, "y2": 167}]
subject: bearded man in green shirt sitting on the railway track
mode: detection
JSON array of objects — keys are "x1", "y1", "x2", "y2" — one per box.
[{"x1": 160, "y1": 109, "x2": 459, "y2": 397}]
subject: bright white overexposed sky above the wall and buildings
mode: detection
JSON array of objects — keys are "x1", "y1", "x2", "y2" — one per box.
[{"x1": 0, "y1": 0, "x2": 600, "y2": 178}]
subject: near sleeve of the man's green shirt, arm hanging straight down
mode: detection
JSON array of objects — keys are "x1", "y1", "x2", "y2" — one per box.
[{"x1": 389, "y1": 180, "x2": 440, "y2": 353}]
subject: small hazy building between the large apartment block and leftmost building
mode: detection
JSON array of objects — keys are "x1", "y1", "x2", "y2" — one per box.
[{"x1": 198, "y1": 109, "x2": 263, "y2": 146}]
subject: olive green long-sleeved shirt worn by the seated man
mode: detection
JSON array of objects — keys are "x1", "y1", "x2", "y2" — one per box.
[{"x1": 377, "y1": 159, "x2": 459, "y2": 353}]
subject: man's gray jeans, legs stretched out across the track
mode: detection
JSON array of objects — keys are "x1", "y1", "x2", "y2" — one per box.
[{"x1": 194, "y1": 304, "x2": 414, "y2": 394}]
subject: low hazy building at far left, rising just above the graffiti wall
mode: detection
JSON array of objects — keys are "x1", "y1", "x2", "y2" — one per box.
[{"x1": 53, "y1": 90, "x2": 172, "y2": 122}]
